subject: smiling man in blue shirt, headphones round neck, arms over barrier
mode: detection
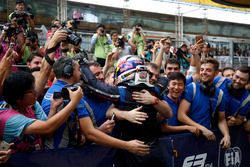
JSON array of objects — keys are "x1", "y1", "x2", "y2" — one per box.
[{"x1": 178, "y1": 58, "x2": 230, "y2": 148}]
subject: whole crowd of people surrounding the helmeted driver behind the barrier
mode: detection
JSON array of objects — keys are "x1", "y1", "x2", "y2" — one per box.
[{"x1": 0, "y1": 0, "x2": 250, "y2": 167}]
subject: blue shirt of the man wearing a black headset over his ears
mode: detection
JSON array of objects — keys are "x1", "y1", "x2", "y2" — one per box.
[{"x1": 42, "y1": 80, "x2": 89, "y2": 148}]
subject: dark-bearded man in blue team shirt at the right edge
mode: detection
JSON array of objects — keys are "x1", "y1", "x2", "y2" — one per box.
[{"x1": 214, "y1": 67, "x2": 250, "y2": 126}]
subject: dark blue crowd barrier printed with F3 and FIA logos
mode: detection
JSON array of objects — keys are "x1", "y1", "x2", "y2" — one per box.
[{"x1": 4, "y1": 127, "x2": 250, "y2": 167}]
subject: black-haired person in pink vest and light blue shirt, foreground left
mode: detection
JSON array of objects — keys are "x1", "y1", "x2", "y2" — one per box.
[{"x1": 0, "y1": 71, "x2": 83, "y2": 152}]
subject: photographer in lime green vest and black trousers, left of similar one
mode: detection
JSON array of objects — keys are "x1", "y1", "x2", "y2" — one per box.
[{"x1": 90, "y1": 24, "x2": 112, "y2": 67}]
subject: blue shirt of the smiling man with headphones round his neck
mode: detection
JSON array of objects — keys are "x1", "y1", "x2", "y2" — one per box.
[{"x1": 184, "y1": 83, "x2": 225, "y2": 129}]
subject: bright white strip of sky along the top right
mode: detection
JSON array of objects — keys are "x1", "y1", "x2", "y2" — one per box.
[{"x1": 69, "y1": 0, "x2": 250, "y2": 25}]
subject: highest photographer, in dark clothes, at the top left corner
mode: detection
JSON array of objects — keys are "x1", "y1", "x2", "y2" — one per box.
[{"x1": 9, "y1": 0, "x2": 35, "y2": 32}]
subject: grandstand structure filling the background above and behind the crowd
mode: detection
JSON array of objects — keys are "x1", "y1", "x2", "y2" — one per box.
[{"x1": 0, "y1": 0, "x2": 250, "y2": 67}]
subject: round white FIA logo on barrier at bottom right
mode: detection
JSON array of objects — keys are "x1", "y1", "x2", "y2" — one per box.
[{"x1": 224, "y1": 147, "x2": 242, "y2": 167}]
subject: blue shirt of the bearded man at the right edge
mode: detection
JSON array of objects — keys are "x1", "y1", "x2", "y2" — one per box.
[{"x1": 214, "y1": 76, "x2": 250, "y2": 116}]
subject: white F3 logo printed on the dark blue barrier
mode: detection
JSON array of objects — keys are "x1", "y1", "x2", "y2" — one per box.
[{"x1": 182, "y1": 153, "x2": 207, "y2": 167}]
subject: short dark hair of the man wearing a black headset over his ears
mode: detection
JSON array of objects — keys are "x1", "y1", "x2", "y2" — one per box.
[{"x1": 53, "y1": 56, "x2": 73, "y2": 79}]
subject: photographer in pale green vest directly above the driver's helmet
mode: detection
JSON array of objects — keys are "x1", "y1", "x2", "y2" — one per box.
[{"x1": 128, "y1": 24, "x2": 146, "y2": 55}]
